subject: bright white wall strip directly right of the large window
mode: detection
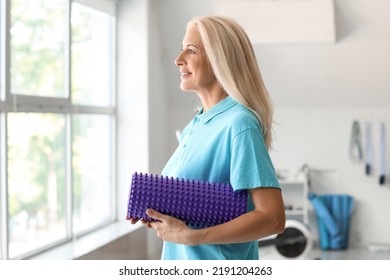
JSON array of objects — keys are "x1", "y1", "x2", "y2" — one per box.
[{"x1": 117, "y1": 0, "x2": 149, "y2": 218}]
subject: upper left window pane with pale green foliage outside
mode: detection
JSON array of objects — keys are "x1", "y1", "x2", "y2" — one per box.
[{"x1": 10, "y1": 0, "x2": 67, "y2": 97}]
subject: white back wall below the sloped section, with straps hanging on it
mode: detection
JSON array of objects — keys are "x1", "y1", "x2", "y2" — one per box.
[{"x1": 271, "y1": 106, "x2": 390, "y2": 244}]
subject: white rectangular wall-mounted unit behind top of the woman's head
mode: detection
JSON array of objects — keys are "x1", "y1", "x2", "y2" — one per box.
[{"x1": 217, "y1": 0, "x2": 336, "y2": 44}]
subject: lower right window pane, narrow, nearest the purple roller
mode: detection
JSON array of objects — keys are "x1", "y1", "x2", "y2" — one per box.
[{"x1": 72, "y1": 115, "x2": 112, "y2": 233}]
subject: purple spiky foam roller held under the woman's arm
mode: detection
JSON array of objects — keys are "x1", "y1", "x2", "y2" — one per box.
[{"x1": 127, "y1": 172, "x2": 247, "y2": 227}]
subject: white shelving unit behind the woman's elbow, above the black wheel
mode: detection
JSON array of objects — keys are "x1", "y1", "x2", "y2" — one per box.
[{"x1": 280, "y1": 180, "x2": 309, "y2": 224}]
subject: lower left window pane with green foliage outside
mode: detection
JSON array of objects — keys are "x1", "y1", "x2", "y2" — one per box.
[{"x1": 8, "y1": 113, "x2": 66, "y2": 258}]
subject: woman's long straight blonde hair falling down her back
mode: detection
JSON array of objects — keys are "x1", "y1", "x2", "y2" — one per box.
[{"x1": 188, "y1": 16, "x2": 273, "y2": 149}]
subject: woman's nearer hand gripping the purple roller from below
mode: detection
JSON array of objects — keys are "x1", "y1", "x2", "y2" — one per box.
[{"x1": 146, "y1": 209, "x2": 197, "y2": 245}]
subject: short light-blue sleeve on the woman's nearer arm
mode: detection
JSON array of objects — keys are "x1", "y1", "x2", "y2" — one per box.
[{"x1": 230, "y1": 128, "x2": 280, "y2": 190}]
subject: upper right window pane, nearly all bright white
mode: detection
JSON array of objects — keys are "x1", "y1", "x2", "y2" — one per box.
[{"x1": 72, "y1": 3, "x2": 112, "y2": 106}]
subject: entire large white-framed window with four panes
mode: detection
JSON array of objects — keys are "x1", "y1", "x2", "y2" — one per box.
[{"x1": 0, "y1": 0, "x2": 116, "y2": 259}]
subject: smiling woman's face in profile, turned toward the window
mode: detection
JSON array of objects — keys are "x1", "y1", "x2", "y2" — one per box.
[{"x1": 175, "y1": 25, "x2": 217, "y2": 94}]
